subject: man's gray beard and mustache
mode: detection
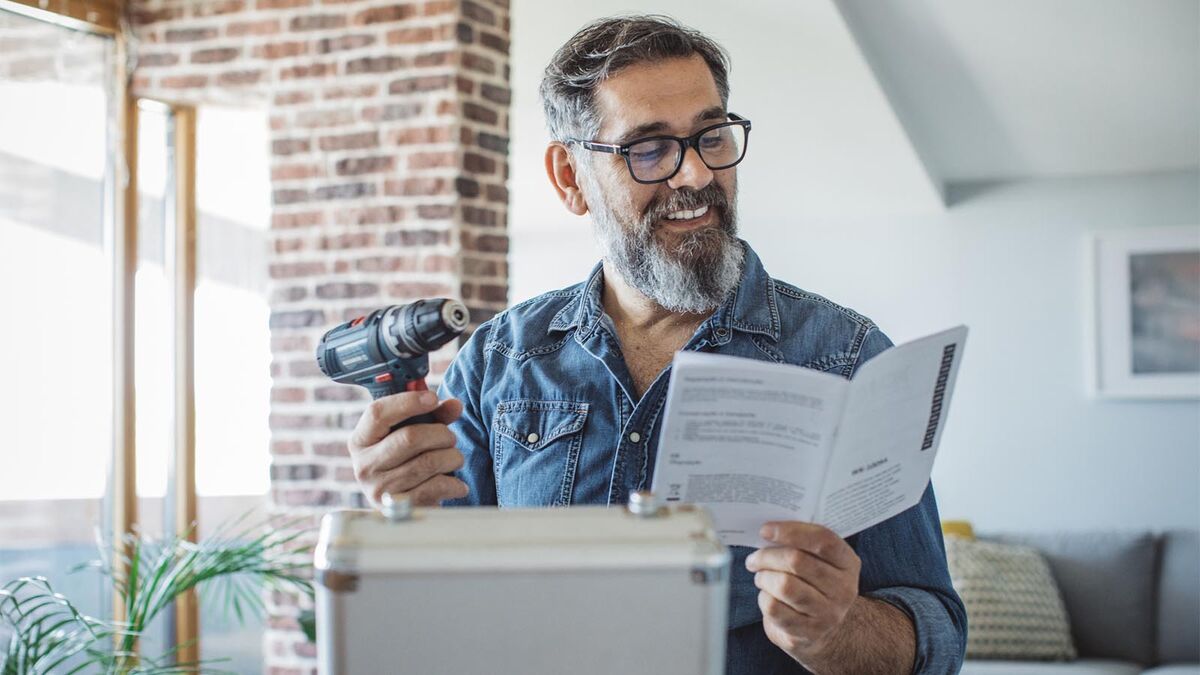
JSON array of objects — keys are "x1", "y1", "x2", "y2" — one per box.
[{"x1": 584, "y1": 177, "x2": 745, "y2": 313}]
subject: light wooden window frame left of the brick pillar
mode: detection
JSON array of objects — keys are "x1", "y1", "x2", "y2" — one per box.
[{"x1": 0, "y1": 0, "x2": 199, "y2": 663}]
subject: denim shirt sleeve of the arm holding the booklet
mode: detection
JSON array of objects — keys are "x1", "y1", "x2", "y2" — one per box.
[{"x1": 848, "y1": 328, "x2": 967, "y2": 675}]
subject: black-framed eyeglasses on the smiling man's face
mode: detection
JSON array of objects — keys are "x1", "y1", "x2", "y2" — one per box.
[{"x1": 566, "y1": 113, "x2": 750, "y2": 184}]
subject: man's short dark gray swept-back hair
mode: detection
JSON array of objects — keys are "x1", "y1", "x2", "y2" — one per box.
[{"x1": 539, "y1": 14, "x2": 730, "y2": 142}]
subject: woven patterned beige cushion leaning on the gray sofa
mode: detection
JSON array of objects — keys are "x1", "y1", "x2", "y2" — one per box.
[{"x1": 946, "y1": 537, "x2": 1075, "y2": 661}]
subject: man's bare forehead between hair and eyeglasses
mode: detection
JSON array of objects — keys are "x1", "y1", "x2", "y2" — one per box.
[{"x1": 595, "y1": 54, "x2": 725, "y2": 142}]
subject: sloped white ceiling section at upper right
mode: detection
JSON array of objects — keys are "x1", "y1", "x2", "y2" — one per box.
[{"x1": 836, "y1": 0, "x2": 1200, "y2": 184}]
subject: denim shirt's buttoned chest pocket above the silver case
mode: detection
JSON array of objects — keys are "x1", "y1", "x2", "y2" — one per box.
[{"x1": 492, "y1": 400, "x2": 588, "y2": 507}]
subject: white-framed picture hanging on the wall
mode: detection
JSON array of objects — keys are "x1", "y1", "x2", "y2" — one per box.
[{"x1": 1091, "y1": 226, "x2": 1200, "y2": 399}]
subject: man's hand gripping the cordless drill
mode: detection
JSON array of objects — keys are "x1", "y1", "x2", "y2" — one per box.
[{"x1": 348, "y1": 392, "x2": 468, "y2": 506}]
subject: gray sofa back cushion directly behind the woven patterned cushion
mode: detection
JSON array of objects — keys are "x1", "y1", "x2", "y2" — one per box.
[{"x1": 995, "y1": 532, "x2": 1157, "y2": 665}]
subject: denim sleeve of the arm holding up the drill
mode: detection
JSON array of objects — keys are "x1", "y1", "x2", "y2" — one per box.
[{"x1": 438, "y1": 323, "x2": 496, "y2": 507}]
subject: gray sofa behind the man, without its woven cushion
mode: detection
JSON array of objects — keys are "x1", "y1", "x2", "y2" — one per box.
[{"x1": 962, "y1": 531, "x2": 1200, "y2": 675}]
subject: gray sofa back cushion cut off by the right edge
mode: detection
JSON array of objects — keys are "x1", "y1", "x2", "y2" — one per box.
[{"x1": 1158, "y1": 530, "x2": 1200, "y2": 663}]
